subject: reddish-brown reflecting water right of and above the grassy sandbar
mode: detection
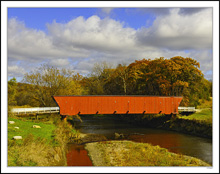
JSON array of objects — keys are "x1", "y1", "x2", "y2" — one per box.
[{"x1": 129, "y1": 133, "x2": 212, "y2": 164}]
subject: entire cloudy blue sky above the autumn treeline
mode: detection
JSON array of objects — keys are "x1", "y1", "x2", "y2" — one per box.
[{"x1": 8, "y1": 7, "x2": 213, "y2": 81}]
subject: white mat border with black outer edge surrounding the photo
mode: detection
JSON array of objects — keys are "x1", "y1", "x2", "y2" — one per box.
[{"x1": 1, "y1": 1, "x2": 219, "y2": 173}]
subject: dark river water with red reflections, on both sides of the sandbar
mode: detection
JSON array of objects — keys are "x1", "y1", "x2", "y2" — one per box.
[{"x1": 67, "y1": 115, "x2": 212, "y2": 166}]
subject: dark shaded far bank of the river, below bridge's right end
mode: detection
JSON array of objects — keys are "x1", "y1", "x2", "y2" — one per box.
[{"x1": 118, "y1": 114, "x2": 212, "y2": 139}]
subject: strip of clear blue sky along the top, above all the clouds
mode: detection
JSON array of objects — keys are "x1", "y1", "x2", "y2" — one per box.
[{"x1": 8, "y1": 8, "x2": 155, "y2": 32}]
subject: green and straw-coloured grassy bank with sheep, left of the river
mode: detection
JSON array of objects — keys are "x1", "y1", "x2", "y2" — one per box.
[{"x1": 8, "y1": 116, "x2": 75, "y2": 166}]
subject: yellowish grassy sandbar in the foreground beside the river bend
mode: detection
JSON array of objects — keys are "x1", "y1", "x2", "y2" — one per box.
[{"x1": 85, "y1": 141, "x2": 210, "y2": 166}]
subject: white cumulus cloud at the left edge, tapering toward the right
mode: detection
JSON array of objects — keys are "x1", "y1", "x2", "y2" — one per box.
[{"x1": 8, "y1": 18, "x2": 87, "y2": 61}]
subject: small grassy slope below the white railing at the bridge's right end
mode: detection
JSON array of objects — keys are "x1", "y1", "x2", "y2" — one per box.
[{"x1": 179, "y1": 109, "x2": 212, "y2": 123}]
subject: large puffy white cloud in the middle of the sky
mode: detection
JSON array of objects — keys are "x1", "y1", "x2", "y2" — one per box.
[{"x1": 47, "y1": 16, "x2": 135, "y2": 52}]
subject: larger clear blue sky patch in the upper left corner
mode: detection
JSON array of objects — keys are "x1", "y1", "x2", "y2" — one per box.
[{"x1": 8, "y1": 8, "x2": 100, "y2": 31}]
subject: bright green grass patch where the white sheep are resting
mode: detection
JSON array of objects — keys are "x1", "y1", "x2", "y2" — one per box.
[{"x1": 8, "y1": 117, "x2": 55, "y2": 142}]
